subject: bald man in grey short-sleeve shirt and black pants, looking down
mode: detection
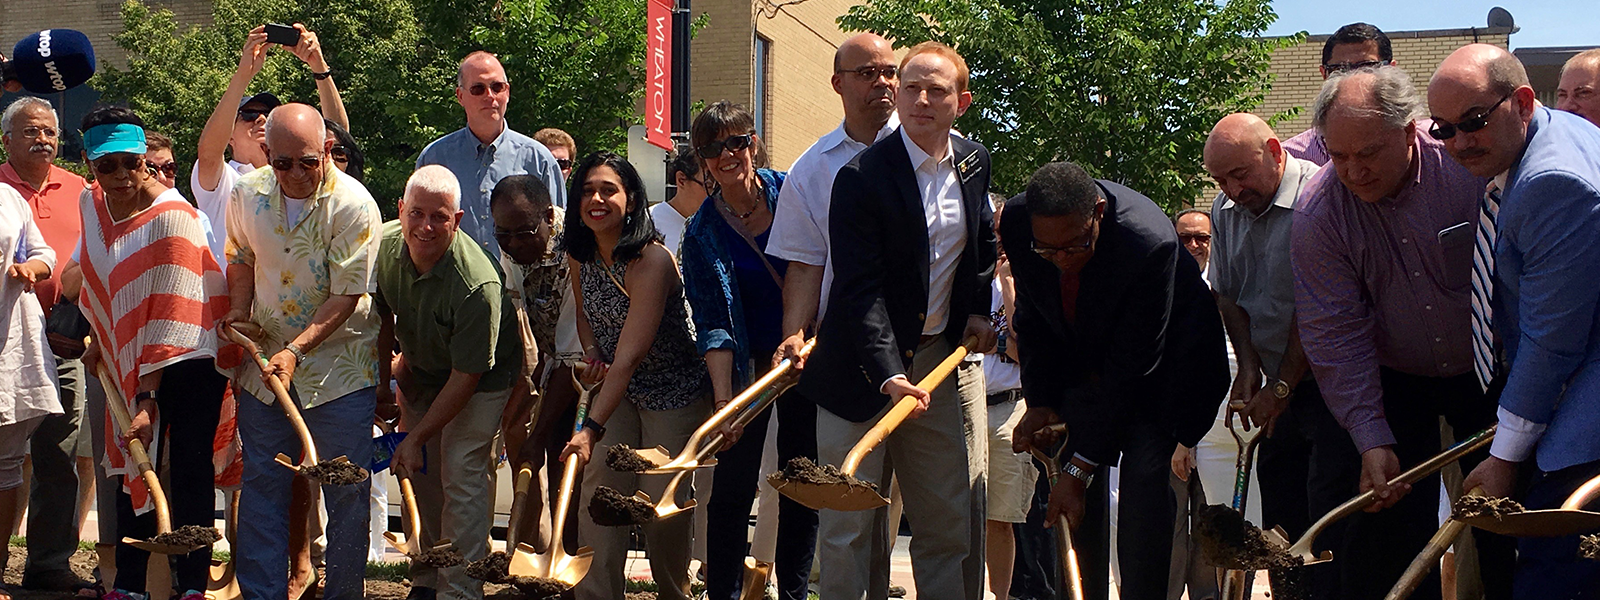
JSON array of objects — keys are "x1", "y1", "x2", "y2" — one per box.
[{"x1": 1203, "y1": 112, "x2": 1360, "y2": 600}]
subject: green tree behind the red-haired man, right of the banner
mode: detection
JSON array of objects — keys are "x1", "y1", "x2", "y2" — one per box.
[{"x1": 838, "y1": 0, "x2": 1299, "y2": 210}]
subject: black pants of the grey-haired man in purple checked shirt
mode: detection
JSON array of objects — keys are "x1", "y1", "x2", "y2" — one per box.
[{"x1": 1334, "y1": 368, "x2": 1515, "y2": 600}]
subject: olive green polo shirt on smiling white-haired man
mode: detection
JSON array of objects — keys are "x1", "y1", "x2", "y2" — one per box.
[{"x1": 374, "y1": 221, "x2": 522, "y2": 403}]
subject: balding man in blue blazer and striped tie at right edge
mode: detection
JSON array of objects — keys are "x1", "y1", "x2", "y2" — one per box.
[{"x1": 1427, "y1": 45, "x2": 1600, "y2": 598}]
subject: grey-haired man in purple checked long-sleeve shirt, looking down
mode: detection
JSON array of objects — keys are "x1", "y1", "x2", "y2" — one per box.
[{"x1": 1290, "y1": 66, "x2": 1514, "y2": 598}]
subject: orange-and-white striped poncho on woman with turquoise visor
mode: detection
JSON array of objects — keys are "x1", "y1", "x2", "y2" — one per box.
[{"x1": 78, "y1": 186, "x2": 242, "y2": 514}]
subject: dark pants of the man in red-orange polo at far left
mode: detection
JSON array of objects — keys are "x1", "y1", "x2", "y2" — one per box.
[{"x1": 22, "y1": 357, "x2": 82, "y2": 586}]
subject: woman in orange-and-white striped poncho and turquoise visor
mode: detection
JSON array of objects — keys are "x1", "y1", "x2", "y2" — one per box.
[{"x1": 75, "y1": 107, "x2": 237, "y2": 600}]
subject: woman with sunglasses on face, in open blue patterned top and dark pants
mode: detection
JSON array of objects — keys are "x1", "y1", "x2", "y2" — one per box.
[{"x1": 678, "y1": 101, "x2": 816, "y2": 600}]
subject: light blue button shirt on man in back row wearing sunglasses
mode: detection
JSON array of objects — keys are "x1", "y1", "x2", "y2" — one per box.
[{"x1": 416, "y1": 125, "x2": 566, "y2": 259}]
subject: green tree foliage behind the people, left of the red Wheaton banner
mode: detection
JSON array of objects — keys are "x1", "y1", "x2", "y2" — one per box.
[{"x1": 91, "y1": 0, "x2": 645, "y2": 209}]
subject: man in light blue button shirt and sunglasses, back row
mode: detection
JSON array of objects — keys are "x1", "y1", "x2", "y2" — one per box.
[{"x1": 416, "y1": 51, "x2": 566, "y2": 258}]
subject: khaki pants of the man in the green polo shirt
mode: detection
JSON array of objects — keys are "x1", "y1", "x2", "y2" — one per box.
[{"x1": 405, "y1": 389, "x2": 510, "y2": 600}]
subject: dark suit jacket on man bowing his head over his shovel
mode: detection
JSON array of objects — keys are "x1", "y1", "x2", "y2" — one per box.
[{"x1": 1000, "y1": 181, "x2": 1229, "y2": 464}]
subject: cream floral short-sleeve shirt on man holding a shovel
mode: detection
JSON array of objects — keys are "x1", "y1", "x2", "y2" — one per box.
[{"x1": 224, "y1": 166, "x2": 382, "y2": 408}]
